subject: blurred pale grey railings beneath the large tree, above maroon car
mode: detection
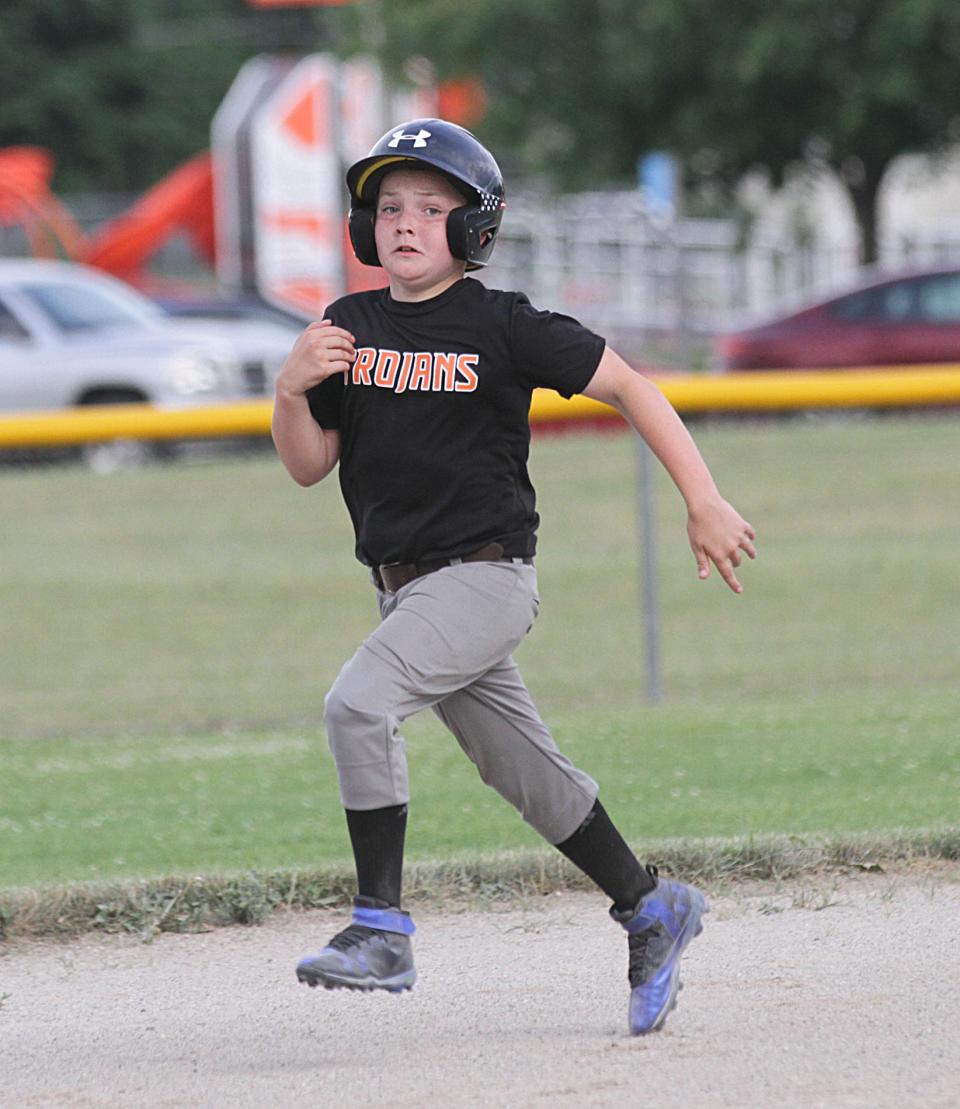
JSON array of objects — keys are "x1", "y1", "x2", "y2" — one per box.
[{"x1": 482, "y1": 192, "x2": 960, "y2": 368}]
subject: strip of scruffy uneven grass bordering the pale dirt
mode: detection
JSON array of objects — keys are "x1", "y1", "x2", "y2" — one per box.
[{"x1": 0, "y1": 825, "x2": 960, "y2": 942}]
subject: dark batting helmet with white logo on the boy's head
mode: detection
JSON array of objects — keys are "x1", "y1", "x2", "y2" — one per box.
[{"x1": 347, "y1": 120, "x2": 504, "y2": 269}]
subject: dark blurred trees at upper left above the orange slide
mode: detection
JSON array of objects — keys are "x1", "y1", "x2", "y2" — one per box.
[{"x1": 0, "y1": 0, "x2": 277, "y2": 191}]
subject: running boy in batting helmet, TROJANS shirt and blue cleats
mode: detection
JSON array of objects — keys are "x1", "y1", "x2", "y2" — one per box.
[{"x1": 273, "y1": 120, "x2": 755, "y2": 1034}]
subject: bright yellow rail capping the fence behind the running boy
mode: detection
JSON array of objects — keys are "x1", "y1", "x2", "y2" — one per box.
[{"x1": 0, "y1": 365, "x2": 960, "y2": 449}]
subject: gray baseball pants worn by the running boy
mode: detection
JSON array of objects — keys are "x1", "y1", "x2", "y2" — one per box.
[{"x1": 324, "y1": 561, "x2": 598, "y2": 844}]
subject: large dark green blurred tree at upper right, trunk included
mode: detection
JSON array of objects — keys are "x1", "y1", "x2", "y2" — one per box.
[{"x1": 360, "y1": 0, "x2": 960, "y2": 263}]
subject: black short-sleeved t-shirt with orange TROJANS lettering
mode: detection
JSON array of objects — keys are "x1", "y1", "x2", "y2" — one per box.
[{"x1": 307, "y1": 278, "x2": 604, "y2": 566}]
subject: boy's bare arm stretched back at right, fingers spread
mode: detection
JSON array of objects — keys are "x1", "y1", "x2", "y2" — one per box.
[{"x1": 583, "y1": 347, "x2": 757, "y2": 593}]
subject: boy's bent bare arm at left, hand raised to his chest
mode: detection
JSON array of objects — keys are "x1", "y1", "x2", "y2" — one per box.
[{"x1": 272, "y1": 319, "x2": 356, "y2": 486}]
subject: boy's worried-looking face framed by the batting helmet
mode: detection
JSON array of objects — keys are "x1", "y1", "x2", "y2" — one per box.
[{"x1": 374, "y1": 170, "x2": 466, "y2": 301}]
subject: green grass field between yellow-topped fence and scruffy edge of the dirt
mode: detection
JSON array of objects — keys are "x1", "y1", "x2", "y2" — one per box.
[{"x1": 0, "y1": 417, "x2": 960, "y2": 886}]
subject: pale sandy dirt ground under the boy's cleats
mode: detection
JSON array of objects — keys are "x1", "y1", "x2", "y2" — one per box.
[{"x1": 0, "y1": 864, "x2": 960, "y2": 1109}]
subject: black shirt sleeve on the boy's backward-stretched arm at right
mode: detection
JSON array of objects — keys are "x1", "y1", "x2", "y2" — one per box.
[{"x1": 510, "y1": 294, "x2": 606, "y2": 397}]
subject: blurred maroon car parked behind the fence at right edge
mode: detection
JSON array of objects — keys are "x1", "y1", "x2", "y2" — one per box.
[{"x1": 717, "y1": 269, "x2": 960, "y2": 370}]
